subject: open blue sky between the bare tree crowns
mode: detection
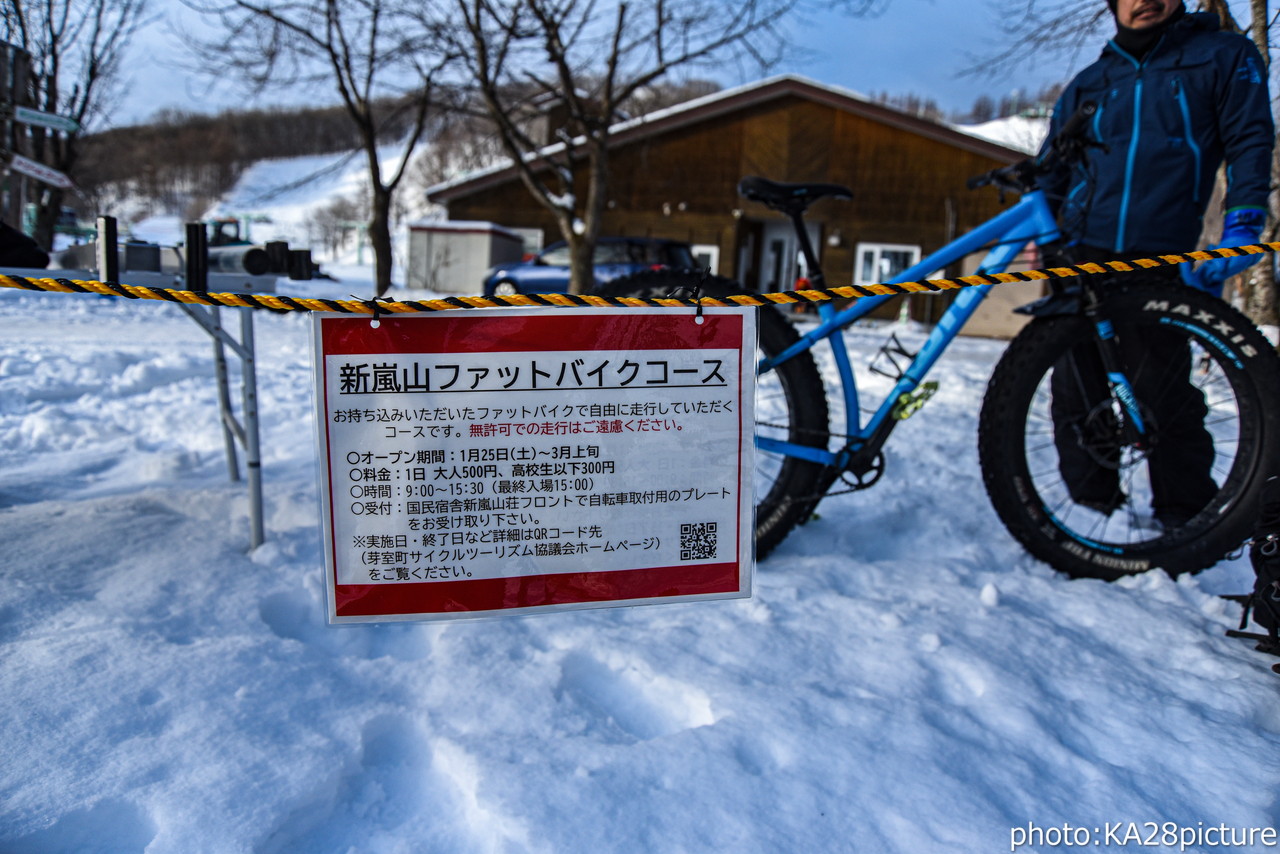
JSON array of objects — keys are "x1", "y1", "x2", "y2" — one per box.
[{"x1": 113, "y1": 0, "x2": 1101, "y2": 124}]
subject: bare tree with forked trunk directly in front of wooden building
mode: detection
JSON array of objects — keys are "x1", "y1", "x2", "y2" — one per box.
[{"x1": 453, "y1": 0, "x2": 879, "y2": 293}]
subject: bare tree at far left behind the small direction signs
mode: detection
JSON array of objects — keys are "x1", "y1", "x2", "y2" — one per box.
[{"x1": 0, "y1": 0, "x2": 147, "y2": 247}]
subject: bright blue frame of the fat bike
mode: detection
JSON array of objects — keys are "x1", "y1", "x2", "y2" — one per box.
[{"x1": 756, "y1": 189, "x2": 1059, "y2": 470}]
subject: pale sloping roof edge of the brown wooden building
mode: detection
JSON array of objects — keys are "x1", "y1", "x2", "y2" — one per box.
[{"x1": 426, "y1": 74, "x2": 1024, "y2": 202}]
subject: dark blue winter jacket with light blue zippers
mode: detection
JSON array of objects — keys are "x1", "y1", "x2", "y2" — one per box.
[{"x1": 1042, "y1": 13, "x2": 1275, "y2": 257}]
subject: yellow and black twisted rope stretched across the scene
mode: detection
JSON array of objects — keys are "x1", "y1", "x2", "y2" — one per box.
[{"x1": 0, "y1": 243, "x2": 1280, "y2": 315}]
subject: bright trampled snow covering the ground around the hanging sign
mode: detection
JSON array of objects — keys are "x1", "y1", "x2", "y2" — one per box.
[{"x1": 0, "y1": 262, "x2": 1280, "y2": 854}]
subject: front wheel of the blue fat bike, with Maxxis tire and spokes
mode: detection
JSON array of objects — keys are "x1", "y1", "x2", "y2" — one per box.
[{"x1": 978, "y1": 283, "x2": 1280, "y2": 581}]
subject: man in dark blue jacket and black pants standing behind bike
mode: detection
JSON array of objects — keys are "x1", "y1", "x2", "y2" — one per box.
[{"x1": 1042, "y1": 0, "x2": 1275, "y2": 528}]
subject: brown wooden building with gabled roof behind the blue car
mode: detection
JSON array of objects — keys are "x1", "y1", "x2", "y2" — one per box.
[{"x1": 429, "y1": 76, "x2": 1024, "y2": 320}]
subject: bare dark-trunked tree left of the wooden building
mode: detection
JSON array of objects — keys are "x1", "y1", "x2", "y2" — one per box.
[{"x1": 183, "y1": 0, "x2": 449, "y2": 296}]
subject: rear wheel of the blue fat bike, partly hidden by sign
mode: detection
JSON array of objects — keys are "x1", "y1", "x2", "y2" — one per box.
[{"x1": 599, "y1": 270, "x2": 828, "y2": 558}]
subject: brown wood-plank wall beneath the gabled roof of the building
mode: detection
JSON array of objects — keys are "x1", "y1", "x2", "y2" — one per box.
[{"x1": 449, "y1": 90, "x2": 1018, "y2": 311}]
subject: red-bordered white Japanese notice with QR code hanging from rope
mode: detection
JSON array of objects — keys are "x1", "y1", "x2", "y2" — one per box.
[{"x1": 314, "y1": 307, "x2": 755, "y2": 622}]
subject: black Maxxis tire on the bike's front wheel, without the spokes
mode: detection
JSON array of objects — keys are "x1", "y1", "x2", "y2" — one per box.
[{"x1": 978, "y1": 283, "x2": 1280, "y2": 580}]
